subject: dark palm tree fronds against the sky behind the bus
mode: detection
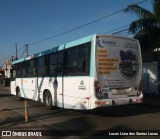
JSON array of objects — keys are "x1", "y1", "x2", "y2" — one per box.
[{"x1": 125, "y1": 0, "x2": 160, "y2": 48}]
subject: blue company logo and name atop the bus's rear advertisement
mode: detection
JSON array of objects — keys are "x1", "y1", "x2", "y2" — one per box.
[{"x1": 97, "y1": 39, "x2": 117, "y2": 48}]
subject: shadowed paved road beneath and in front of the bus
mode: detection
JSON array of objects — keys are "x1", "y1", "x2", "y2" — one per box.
[{"x1": 0, "y1": 87, "x2": 160, "y2": 137}]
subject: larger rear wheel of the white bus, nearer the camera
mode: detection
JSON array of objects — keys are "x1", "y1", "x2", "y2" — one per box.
[{"x1": 43, "y1": 90, "x2": 53, "y2": 109}]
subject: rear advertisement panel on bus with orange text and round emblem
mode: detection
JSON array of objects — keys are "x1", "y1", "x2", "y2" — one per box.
[{"x1": 96, "y1": 36, "x2": 141, "y2": 88}]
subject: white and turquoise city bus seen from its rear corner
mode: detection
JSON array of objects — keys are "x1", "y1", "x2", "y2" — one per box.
[{"x1": 11, "y1": 34, "x2": 143, "y2": 110}]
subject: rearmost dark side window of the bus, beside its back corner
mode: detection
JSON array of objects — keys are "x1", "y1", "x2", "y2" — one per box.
[{"x1": 64, "y1": 42, "x2": 91, "y2": 76}]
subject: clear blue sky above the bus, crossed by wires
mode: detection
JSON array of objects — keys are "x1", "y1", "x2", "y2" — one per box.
[{"x1": 0, "y1": 0, "x2": 152, "y2": 66}]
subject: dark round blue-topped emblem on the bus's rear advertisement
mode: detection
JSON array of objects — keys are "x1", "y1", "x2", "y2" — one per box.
[{"x1": 119, "y1": 50, "x2": 138, "y2": 79}]
